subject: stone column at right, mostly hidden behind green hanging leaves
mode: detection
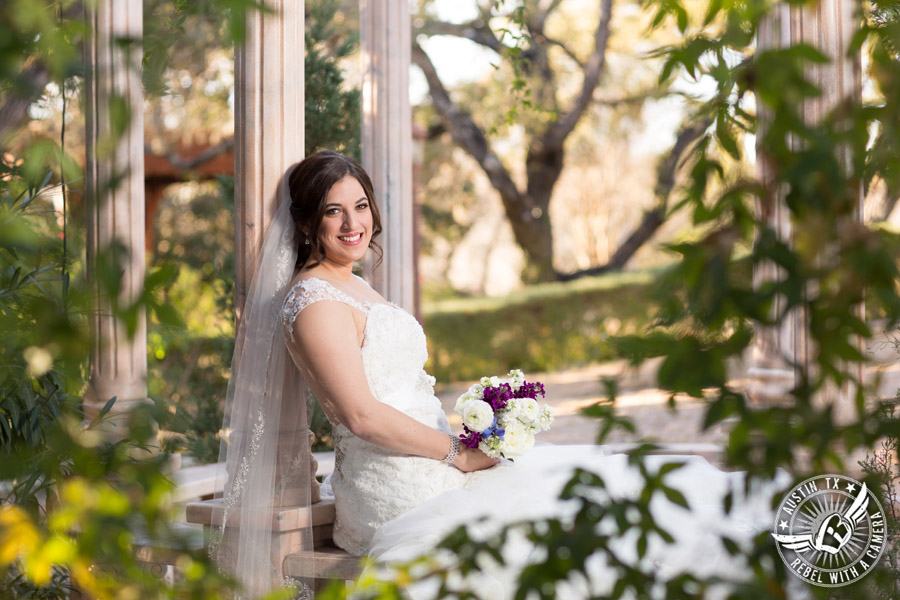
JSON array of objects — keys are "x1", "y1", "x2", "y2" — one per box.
[{"x1": 749, "y1": 0, "x2": 864, "y2": 422}]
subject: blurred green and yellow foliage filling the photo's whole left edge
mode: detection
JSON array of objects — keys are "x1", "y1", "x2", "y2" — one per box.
[{"x1": 0, "y1": 0, "x2": 286, "y2": 600}]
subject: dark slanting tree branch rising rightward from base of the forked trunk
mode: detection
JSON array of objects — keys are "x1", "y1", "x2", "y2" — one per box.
[{"x1": 558, "y1": 118, "x2": 712, "y2": 281}]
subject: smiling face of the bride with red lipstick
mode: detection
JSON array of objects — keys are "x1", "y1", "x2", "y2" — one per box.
[{"x1": 319, "y1": 175, "x2": 372, "y2": 264}]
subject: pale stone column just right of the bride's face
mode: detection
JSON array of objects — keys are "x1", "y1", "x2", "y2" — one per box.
[{"x1": 359, "y1": 0, "x2": 417, "y2": 313}]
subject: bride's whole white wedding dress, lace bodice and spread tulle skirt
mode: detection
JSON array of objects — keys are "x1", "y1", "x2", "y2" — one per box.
[{"x1": 282, "y1": 278, "x2": 772, "y2": 598}]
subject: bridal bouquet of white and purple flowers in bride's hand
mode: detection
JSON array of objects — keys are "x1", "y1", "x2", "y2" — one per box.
[{"x1": 453, "y1": 369, "x2": 553, "y2": 459}]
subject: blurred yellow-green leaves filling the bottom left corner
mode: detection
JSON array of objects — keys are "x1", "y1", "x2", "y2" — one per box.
[{"x1": 0, "y1": 409, "x2": 243, "y2": 600}]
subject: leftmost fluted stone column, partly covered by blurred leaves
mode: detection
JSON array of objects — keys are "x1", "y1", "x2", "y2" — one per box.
[{"x1": 84, "y1": 0, "x2": 148, "y2": 436}]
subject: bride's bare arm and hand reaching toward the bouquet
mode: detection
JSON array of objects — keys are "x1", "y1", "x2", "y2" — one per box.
[{"x1": 288, "y1": 301, "x2": 498, "y2": 471}]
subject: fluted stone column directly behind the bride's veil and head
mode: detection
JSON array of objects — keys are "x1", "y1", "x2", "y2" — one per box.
[{"x1": 234, "y1": 0, "x2": 319, "y2": 508}]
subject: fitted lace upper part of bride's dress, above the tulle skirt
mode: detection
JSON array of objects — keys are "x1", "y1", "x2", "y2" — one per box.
[{"x1": 281, "y1": 277, "x2": 464, "y2": 555}]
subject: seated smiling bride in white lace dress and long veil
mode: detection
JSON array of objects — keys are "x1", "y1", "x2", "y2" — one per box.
[{"x1": 211, "y1": 151, "x2": 769, "y2": 598}]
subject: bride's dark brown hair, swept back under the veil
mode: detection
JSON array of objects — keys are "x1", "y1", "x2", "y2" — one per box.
[{"x1": 288, "y1": 150, "x2": 382, "y2": 269}]
